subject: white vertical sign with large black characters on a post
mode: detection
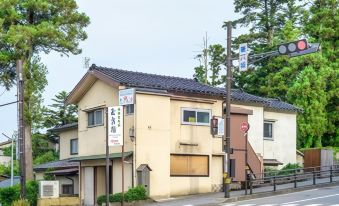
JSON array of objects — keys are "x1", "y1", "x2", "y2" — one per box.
[{"x1": 108, "y1": 106, "x2": 124, "y2": 147}]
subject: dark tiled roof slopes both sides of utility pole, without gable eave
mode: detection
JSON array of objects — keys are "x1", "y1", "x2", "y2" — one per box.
[{"x1": 90, "y1": 64, "x2": 301, "y2": 112}]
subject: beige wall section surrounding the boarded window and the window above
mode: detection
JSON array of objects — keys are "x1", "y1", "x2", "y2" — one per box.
[{"x1": 170, "y1": 100, "x2": 222, "y2": 196}]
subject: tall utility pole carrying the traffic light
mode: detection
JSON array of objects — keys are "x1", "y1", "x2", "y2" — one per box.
[{"x1": 224, "y1": 21, "x2": 232, "y2": 198}]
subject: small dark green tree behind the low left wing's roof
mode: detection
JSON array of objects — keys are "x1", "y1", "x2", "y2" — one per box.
[{"x1": 44, "y1": 91, "x2": 78, "y2": 128}]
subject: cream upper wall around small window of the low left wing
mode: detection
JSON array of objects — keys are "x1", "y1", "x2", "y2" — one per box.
[{"x1": 59, "y1": 128, "x2": 79, "y2": 160}]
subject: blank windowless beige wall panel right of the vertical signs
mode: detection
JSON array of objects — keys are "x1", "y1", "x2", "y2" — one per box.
[{"x1": 135, "y1": 94, "x2": 171, "y2": 198}]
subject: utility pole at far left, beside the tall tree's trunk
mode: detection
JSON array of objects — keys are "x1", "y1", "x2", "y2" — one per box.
[{"x1": 16, "y1": 60, "x2": 26, "y2": 199}]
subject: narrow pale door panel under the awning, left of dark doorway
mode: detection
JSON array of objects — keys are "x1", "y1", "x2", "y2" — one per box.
[{"x1": 84, "y1": 167, "x2": 94, "y2": 206}]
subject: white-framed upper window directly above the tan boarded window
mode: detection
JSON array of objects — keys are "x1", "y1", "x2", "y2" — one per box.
[{"x1": 181, "y1": 108, "x2": 211, "y2": 126}]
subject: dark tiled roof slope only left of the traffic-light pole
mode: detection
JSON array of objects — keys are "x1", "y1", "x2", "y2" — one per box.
[{"x1": 90, "y1": 65, "x2": 222, "y2": 96}]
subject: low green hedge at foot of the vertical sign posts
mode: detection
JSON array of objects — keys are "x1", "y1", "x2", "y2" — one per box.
[{"x1": 97, "y1": 185, "x2": 148, "y2": 205}]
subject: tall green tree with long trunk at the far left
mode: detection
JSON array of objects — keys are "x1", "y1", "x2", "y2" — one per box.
[{"x1": 0, "y1": 0, "x2": 89, "y2": 179}]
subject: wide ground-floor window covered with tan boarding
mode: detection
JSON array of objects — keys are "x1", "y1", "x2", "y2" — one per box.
[{"x1": 171, "y1": 154, "x2": 209, "y2": 177}]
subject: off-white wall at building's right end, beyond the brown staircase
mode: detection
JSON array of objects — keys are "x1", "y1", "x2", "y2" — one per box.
[{"x1": 263, "y1": 111, "x2": 297, "y2": 168}]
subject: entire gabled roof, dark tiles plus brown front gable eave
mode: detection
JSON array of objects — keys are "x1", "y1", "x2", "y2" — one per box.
[{"x1": 67, "y1": 64, "x2": 301, "y2": 112}]
